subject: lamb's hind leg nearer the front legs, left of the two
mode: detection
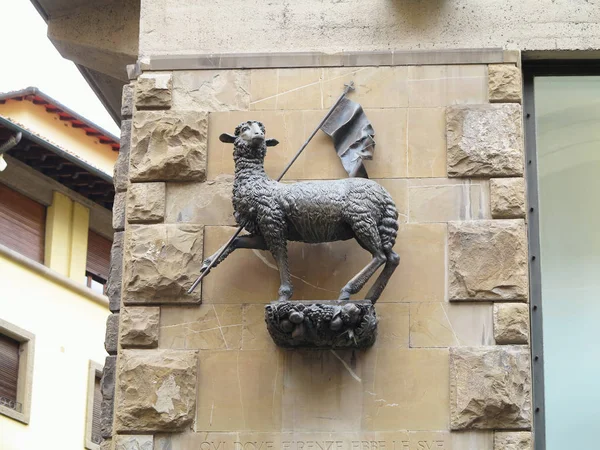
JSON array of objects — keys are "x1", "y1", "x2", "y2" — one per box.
[{"x1": 339, "y1": 220, "x2": 386, "y2": 300}]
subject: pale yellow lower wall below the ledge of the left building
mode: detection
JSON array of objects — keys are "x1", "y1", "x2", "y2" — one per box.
[{"x1": 0, "y1": 251, "x2": 109, "y2": 450}]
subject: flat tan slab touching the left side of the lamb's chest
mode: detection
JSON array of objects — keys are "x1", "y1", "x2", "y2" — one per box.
[{"x1": 165, "y1": 175, "x2": 236, "y2": 225}]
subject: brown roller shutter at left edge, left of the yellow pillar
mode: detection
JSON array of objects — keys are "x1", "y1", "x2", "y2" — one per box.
[{"x1": 0, "y1": 183, "x2": 46, "y2": 263}]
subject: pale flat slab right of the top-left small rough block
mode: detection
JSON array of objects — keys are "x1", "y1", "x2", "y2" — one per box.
[{"x1": 173, "y1": 70, "x2": 250, "y2": 111}]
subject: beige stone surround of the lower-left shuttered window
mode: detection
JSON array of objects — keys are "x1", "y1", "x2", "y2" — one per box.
[{"x1": 0, "y1": 319, "x2": 35, "y2": 425}]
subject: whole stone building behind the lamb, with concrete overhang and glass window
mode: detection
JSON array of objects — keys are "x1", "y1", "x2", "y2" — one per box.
[{"x1": 25, "y1": 0, "x2": 600, "y2": 450}]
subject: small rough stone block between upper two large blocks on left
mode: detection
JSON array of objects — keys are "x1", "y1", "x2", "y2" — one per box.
[{"x1": 127, "y1": 182, "x2": 166, "y2": 223}]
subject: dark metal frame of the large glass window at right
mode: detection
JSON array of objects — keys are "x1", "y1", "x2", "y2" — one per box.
[{"x1": 523, "y1": 59, "x2": 600, "y2": 450}]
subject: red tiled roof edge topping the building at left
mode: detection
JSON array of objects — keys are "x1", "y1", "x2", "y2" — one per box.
[{"x1": 0, "y1": 87, "x2": 121, "y2": 151}]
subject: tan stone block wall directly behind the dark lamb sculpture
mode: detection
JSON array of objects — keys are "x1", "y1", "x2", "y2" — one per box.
[{"x1": 103, "y1": 59, "x2": 532, "y2": 450}]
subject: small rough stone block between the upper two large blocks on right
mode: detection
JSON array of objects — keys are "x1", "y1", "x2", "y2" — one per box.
[{"x1": 490, "y1": 178, "x2": 525, "y2": 219}]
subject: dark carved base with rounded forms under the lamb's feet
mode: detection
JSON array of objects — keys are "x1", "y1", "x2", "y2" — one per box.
[{"x1": 265, "y1": 300, "x2": 377, "y2": 348}]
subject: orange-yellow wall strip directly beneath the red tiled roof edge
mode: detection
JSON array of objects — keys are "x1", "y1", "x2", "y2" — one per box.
[{"x1": 0, "y1": 100, "x2": 118, "y2": 176}]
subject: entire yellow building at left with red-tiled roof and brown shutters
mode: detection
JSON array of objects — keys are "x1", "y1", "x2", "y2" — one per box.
[{"x1": 0, "y1": 88, "x2": 119, "y2": 450}]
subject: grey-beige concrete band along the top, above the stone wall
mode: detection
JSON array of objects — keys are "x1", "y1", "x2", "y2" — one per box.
[{"x1": 139, "y1": 0, "x2": 600, "y2": 58}]
